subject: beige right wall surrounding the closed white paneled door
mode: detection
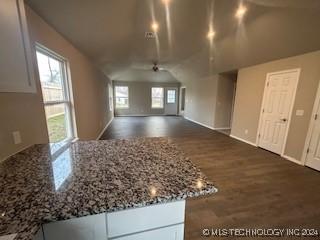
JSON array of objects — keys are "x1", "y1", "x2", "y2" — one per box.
[{"x1": 231, "y1": 51, "x2": 320, "y2": 160}]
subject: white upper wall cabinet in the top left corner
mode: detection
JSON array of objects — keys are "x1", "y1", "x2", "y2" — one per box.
[{"x1": 0, "y1": 0, "x2": 35, "y2": 92}]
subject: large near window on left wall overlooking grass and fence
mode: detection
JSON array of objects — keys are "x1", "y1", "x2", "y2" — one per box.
[{"x1": 36, "y1": 46, "x2": 74, "y2": 146}]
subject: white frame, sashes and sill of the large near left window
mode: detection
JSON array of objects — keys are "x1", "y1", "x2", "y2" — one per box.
[{"x1": 35, "y1": 43, "x2": 77, "y2": 147}]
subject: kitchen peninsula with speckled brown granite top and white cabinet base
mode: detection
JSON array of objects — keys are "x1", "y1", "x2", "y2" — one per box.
[{"x1": 0, "y1": 138, "x2": 217, "y2": 240}]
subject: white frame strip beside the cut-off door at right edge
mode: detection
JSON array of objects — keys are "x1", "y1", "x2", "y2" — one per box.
[{"x1": 301, "y1": 82, "x2": 320, "y2": 166}]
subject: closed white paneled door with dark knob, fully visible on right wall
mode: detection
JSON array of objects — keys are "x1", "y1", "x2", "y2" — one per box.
[{"x1": 258, "y1": 69, "x2": 300, "y2": 154}]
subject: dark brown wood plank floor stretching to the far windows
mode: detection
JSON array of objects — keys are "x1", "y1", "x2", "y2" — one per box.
[{"x1": 101, "y1": 117, "x2": 320, "y2": 240}]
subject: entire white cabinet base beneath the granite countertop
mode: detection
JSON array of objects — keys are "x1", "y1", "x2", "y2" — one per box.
[{"x1": 43, "y1": 201, "x2": 185, "y2": 240}]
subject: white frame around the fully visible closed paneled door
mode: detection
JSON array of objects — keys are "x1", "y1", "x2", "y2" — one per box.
[{"x1": 256, "y1": 68, "x2": 301, "y2": 157}]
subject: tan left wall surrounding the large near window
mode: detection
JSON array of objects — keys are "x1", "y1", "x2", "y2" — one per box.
[{"x1": 0, "y1": 6, "x2": 112, "y2": 160}]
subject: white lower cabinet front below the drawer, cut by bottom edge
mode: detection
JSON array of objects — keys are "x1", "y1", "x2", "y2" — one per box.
[{"x1": 116, "y1": 224, "x2": 184, "y2": 240}]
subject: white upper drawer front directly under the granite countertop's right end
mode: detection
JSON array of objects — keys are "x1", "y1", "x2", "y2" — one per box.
[{"x1": 107, "y1": 201, "x2": 185, "y2": 238}]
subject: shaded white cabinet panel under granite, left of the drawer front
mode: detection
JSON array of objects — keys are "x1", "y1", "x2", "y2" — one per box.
[{"x1": 43, "y1": 214, "x2": 107, "y2": 240}]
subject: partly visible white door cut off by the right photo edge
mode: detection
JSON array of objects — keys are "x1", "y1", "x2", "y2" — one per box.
[{"x1": 306, "y1": 85, "x2": 320, "y2": 171}]
